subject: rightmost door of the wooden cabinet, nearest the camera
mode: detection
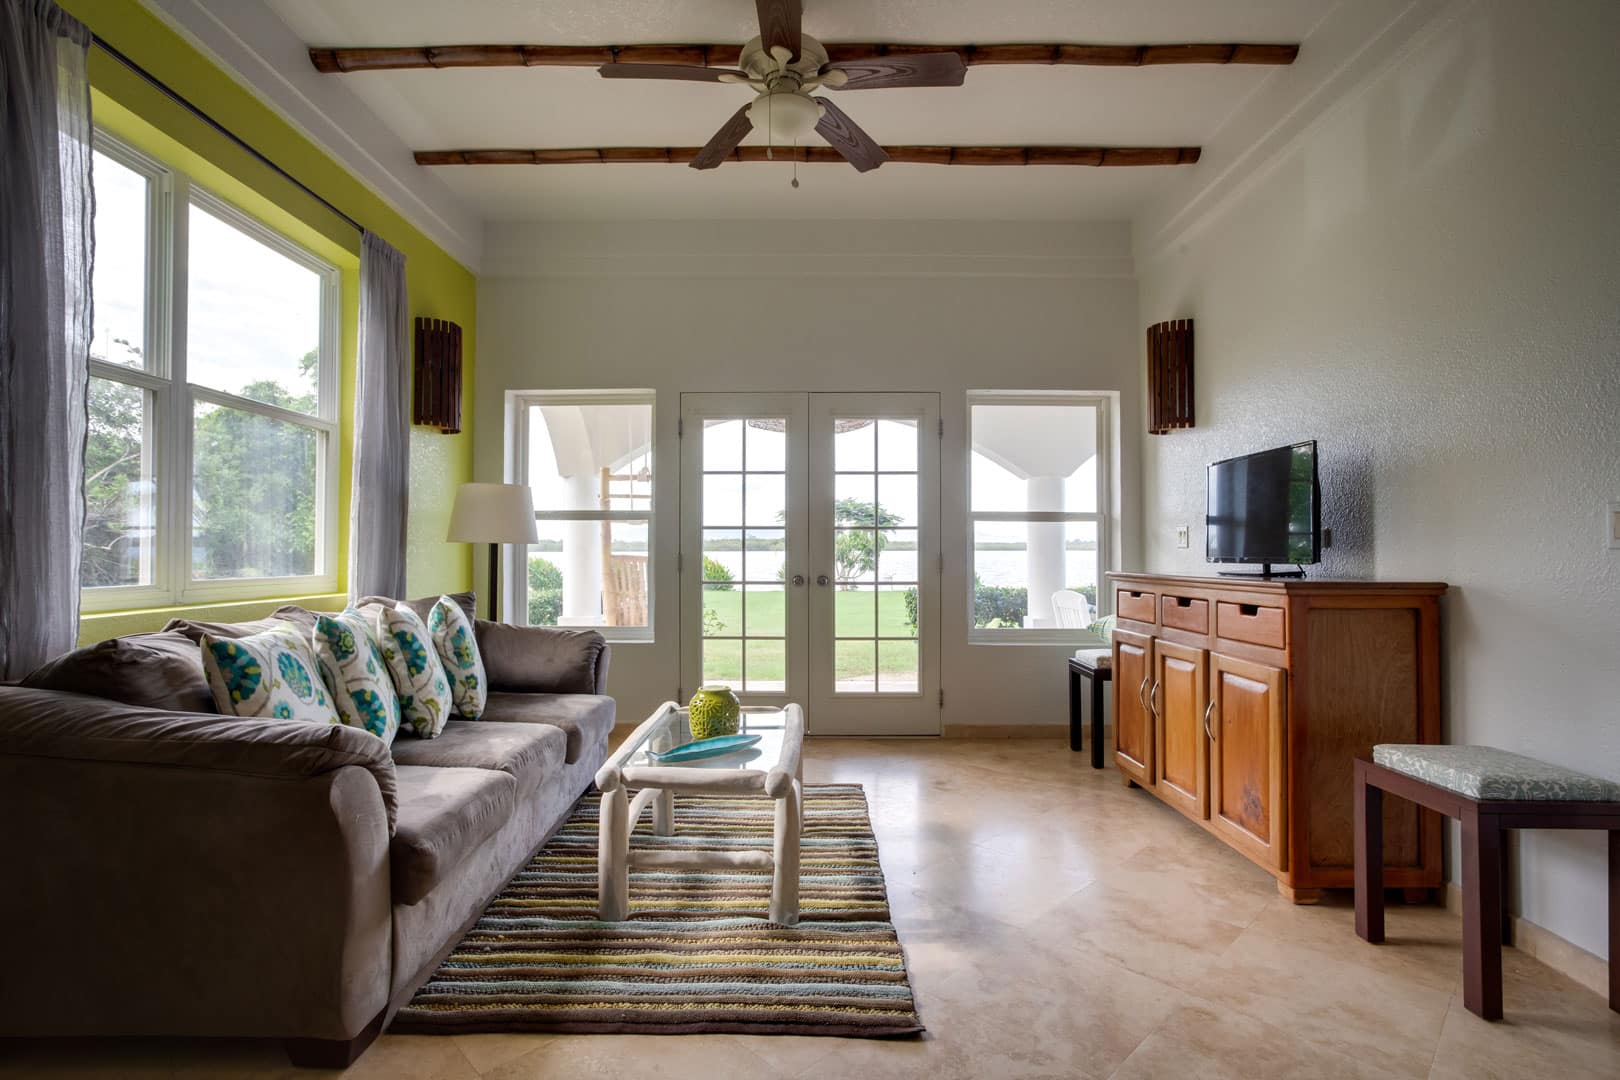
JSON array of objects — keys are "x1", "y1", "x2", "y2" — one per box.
[{"x1": 1209, "y1": 653, "x2": 1288, "y2": 870}]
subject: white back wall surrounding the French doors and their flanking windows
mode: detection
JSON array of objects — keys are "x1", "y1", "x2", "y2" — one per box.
[{"x1": 475, "y1": 222, "x2": 1140, "y2": 735}]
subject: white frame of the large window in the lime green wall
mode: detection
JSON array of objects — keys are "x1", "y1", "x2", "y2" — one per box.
[{"x1": 79, "y1": 128, "x2": 342, "y2": 612}]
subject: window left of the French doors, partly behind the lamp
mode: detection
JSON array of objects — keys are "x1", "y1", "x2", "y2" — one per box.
[{"x1": 510, "y1": 390, "x2": 653, "y2": 641}]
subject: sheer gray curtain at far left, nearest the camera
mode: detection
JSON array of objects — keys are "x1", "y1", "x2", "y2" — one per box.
[{"x1": 0, "y1": 0, "x2": 94, "y2": 678}]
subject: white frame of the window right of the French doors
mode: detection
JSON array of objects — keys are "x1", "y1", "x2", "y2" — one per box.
[{"x1": 964, "y1": 390, "x2": 1113, "y2": 646}]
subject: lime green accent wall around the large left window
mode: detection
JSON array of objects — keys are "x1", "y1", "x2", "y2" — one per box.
[{"x1": 71, "y1": 0, "x2": 478, "y2": 641}]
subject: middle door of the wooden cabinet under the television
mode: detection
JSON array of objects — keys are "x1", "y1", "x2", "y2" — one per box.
[{"x1": 1147, "y1": 641, "x2": 1210, "y2": 821}]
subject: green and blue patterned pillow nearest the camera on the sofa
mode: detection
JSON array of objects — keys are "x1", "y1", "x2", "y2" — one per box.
[{"x1": 201, "y1": 622, "x2": 339, "y2": 724}]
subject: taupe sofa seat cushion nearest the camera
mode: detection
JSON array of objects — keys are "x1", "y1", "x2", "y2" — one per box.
[{"x1": 389, "y1": 764, "x2": 517, "y2": 905}]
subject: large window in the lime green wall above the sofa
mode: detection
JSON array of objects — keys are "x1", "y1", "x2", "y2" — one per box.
[{"x1": 79, "y1": 133, "x2": 339, "y2": 610}]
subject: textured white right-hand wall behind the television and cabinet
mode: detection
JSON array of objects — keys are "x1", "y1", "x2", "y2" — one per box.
[{"x1": 1137, "y1": 0, "x2": 1620, "y2": 955}]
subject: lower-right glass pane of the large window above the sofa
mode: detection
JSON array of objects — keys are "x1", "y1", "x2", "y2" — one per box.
[{"x1": 191, "y1": 403, "x2": 326, "y2": 580}]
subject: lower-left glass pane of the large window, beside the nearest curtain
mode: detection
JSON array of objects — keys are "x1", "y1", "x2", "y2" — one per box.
[{"x1": 79, "y1": 375, "x2": 157, "y2": 588}]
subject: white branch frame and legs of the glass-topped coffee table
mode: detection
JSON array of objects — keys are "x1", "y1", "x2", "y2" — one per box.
[{"x1": 596, "y1": 701, "x2": 805, "y2": 926}]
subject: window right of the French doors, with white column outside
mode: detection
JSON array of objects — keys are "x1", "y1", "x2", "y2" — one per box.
[{"x1": 967, "y1": 392, "x2": 1110, "y2": 643}]
